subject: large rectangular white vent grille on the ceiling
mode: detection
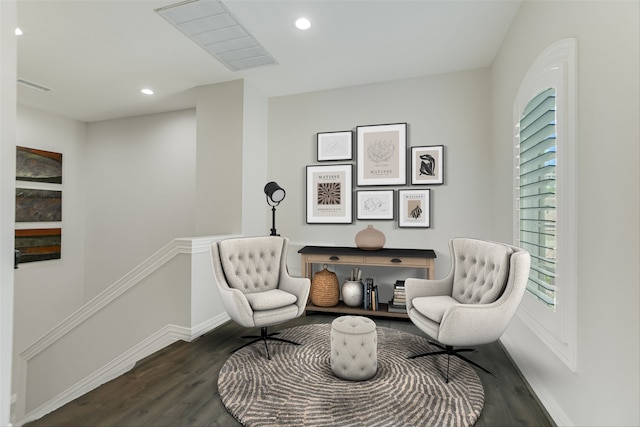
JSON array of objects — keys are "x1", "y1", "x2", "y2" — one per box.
[{"x1": 155, "y1": 0, "x2": 277, "y2": 71}]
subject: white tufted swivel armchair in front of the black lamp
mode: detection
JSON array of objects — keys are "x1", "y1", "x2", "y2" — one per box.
[{"x1": 210, "y1": 236, "x2": 311, "y2": 359}]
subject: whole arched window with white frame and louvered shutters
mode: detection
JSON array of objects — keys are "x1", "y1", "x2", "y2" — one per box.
[{"x1": 514, "y1": 39, "x2": 578, "y2": 371}]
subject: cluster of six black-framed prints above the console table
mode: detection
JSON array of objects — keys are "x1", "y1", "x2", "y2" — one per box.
[{"x1": 306, "y1": 123, "x2": 445, "y2": 228}]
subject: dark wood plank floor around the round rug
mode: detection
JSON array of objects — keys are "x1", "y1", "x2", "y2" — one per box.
[{"x1": 26, "y1": 313, "x2": 555, "y2": 427}]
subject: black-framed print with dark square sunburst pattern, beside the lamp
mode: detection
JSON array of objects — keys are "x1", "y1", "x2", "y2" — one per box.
[{"x1": 306, "y1": 164, "x2": 353, "y2": 224}]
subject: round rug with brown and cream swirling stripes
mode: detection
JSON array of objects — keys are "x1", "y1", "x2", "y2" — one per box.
[{"x1": 218, "y1": 324, "x2": 484, "y2": 427}]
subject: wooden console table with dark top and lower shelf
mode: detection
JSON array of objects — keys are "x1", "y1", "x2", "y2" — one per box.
[{"x1": 298, "y1": 246, "x2": 436, "y2": 318}]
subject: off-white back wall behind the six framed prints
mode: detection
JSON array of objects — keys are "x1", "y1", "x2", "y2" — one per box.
[{"x1": 269, "y1": 69, "x2": 492, "y2": 283}]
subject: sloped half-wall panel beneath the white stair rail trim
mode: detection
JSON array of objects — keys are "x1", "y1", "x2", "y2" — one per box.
[{"x1": 25, "y1": 255, "x2": 191, "y2": 413}]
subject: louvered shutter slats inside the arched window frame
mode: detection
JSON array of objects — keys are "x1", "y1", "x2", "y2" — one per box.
[{"x1": 519, "y1": 88, "x2": 556, "y2": 308}]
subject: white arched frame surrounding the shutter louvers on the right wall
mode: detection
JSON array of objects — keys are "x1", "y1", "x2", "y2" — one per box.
[{"x1": 513, "y1": 38, "x2": 578, "y2": 372}]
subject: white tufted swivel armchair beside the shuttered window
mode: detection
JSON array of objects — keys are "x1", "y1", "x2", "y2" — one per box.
[{"x1": 405, "y1": 238, "x2": 531, "y2": 382}]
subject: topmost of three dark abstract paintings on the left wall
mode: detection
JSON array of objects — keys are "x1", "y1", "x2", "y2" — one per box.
[{"x1": 16, "y1": 146, "x2": 62, "y2": 184}]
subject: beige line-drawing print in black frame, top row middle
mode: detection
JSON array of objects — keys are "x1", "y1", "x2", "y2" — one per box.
[{"x1": 356, "y1": 123, "x2": 407, "y2": 186}]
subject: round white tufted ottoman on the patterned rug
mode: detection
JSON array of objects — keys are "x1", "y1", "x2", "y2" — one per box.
[{"x1": 331, "y1": 316, "x2": 378, "y2": 381}]
